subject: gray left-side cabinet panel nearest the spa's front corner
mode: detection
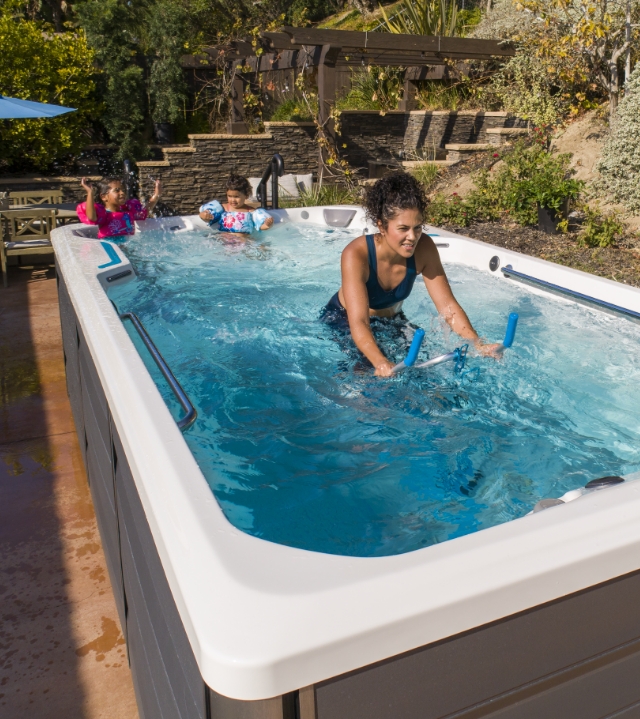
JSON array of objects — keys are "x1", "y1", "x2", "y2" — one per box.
[{"x1": 112, "y1": 426, "x2": 207, "y2": 719}]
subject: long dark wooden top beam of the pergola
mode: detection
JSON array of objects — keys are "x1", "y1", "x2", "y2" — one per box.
[{"x1": 282, "y1": 27, "x2": 515, "y2": 58}]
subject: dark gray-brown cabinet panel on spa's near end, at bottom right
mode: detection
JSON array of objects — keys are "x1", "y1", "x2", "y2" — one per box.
[{"x1": 312, "y1": 573, "x2": 640, "y2": 719}]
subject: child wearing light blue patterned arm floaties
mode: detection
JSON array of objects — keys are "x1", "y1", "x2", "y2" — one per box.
[{"x1": 200, "y1": 173, "x2": 273, "y2": 234}]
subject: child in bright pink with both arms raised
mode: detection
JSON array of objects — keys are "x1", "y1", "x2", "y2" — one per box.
[{"x1": 76, "y1": 177, "x2": 162, "y2": 239}]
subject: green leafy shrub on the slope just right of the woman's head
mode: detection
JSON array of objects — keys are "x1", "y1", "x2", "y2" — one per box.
[{"x1": 428, "y1": 141, "x2": 584, "y2": 227}]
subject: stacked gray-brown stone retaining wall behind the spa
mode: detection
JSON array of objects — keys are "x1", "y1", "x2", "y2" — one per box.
[{"x1": 0, "y1": 110, "x2": 526, "y2": 214}]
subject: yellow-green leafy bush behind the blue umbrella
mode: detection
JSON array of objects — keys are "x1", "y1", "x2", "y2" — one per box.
[{"x1": 0, "y1": 7, "x2": 99, "y2": 170}]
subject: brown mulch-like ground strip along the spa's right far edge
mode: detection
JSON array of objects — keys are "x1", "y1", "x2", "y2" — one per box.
[{"x1": 446, "y1": 222, "x2": 640, "y2": 287}]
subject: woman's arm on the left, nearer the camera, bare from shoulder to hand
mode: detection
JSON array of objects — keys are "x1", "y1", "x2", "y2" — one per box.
[{"x1": 341, "y1": 238, "x2": 393, "y2": 377}]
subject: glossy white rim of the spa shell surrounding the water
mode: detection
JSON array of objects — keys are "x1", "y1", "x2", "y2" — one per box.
[{"x1": 52, "y1": 208, "x2": 640, "y2": 700}]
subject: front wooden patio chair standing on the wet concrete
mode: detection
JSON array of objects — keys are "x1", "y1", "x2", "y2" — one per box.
[{"x1": 0, "y1": 208, "x2": 56, "y2": 287}]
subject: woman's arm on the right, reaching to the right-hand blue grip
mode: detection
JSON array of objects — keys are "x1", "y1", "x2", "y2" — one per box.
[{"x1": 416, "y1": 235, "x2": 501, "y2": 354}]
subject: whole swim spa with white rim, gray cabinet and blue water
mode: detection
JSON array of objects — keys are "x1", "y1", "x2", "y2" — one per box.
[{"x1": 54, "y1": 208, "x2": 640, "y2": 719}]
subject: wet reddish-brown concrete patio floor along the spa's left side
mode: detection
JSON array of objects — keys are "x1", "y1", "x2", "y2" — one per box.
[{"x1": 0, "y1": 268, "x2": 138, "y2": 719}]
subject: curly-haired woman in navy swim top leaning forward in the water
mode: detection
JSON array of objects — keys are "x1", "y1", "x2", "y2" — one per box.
[{"x1": 322, "y1": 172, "x2": 501, "y2": 377}]
